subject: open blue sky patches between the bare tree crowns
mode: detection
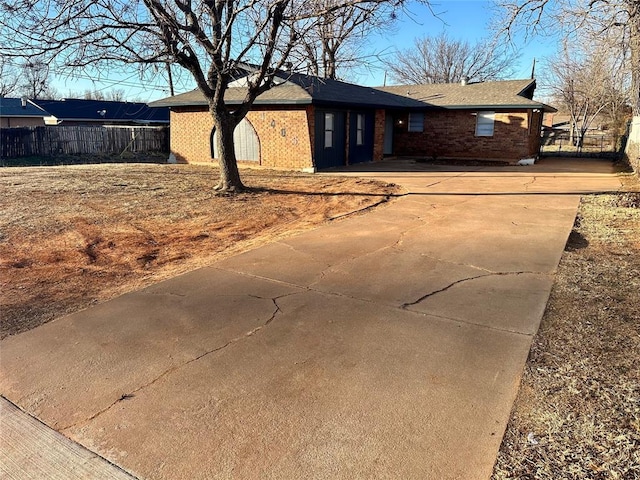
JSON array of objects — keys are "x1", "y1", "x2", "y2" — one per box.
[{"x1": 53, "y1": 0, "x2": 556, "y2": 102}]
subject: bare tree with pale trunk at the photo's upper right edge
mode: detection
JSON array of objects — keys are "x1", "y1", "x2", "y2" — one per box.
[{"x1": 495, "y1": 0, "x2": 640, "y2": 115}]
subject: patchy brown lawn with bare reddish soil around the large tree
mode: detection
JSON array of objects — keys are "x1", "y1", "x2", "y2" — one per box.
[{"x1": 0, "y1": 164, "x2": 397, "y2": 337}]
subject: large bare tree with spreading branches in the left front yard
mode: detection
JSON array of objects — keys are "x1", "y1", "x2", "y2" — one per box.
[{"x1": 0, "y1": 0, "x2": 426, "y2": 192}]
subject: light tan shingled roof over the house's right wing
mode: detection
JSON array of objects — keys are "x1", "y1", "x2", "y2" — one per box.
[{"x1": 380, "y1": 79, "x2": 555, "y2": 112}]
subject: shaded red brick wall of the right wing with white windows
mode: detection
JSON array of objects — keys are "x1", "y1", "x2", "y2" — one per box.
[{"x1": 394, "y1": 110, "x2": 539, "y2": 161}]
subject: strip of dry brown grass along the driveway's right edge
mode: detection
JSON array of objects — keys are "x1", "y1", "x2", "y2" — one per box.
[{"x1": 493, "y1": 180, "x2": 640, "y2": 479}]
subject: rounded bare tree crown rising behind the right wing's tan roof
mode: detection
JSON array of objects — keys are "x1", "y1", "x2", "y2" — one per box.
[{"x1": 385, "y1": 33, "x2": 517, "y2": 84}]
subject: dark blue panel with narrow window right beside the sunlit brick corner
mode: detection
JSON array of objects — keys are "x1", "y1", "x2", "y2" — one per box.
[{"x1": 315, "y1": 110, "x2": 345, "y2": 169}]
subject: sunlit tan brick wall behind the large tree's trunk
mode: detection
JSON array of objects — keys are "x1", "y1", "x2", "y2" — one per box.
[{"x1": 171, "y1": 106, "x2": 313, "y2": 170}]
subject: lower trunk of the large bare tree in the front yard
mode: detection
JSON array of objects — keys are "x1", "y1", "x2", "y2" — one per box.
[{"x1": 213, "y1": 112, "x2": 245, "y2": 193}]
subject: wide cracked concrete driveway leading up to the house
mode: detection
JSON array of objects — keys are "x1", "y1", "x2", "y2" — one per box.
[{"x1": 0, "y1": 157, "x2": 620, "y2": 479}]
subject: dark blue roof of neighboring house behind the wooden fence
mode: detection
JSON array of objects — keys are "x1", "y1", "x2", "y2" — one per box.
[{"x1": 34, "y1": 98, "x2": 169, "y2": 123}]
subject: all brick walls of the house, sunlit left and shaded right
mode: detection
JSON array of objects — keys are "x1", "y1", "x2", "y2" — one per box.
[{"x1": 171, "y1": 105, "x2": 542, "y2": 170}]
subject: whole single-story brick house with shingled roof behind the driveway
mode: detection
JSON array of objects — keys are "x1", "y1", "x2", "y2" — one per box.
[{"x1": 150, "y1": 73, "x2": 554, "y2": 171}]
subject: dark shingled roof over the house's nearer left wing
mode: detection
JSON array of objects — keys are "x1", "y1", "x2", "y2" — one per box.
[{"x1": 149, "y1": 72, "x2": 424, "y2": 108}]
